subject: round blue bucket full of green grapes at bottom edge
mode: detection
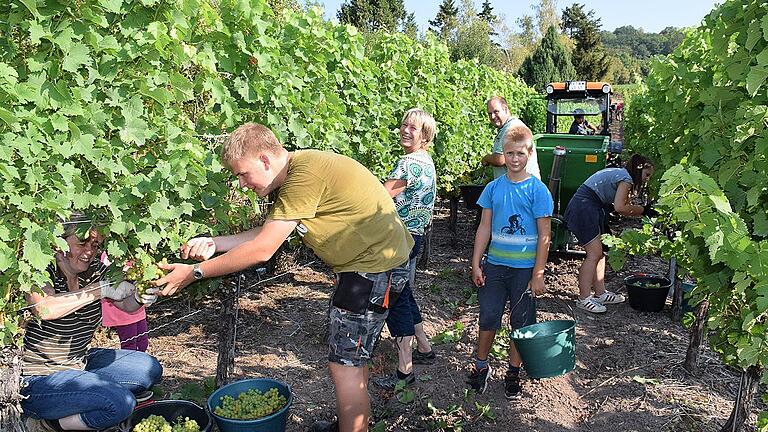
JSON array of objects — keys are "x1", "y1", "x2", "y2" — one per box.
[{"x1": 208, "y1": 378, "x2": 293, "y2": 432}]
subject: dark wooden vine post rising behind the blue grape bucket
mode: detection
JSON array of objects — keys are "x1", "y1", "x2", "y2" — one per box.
[{"x1": 216, "y1": 273, "x2": 245, "y2": 388}]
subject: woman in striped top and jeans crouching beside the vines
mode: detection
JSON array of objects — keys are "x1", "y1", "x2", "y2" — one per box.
[{"x1": 21, "y1": 214, "x2": 162, "y2": 431}]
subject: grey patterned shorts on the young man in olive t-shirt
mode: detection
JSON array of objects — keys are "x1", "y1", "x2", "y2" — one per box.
[{"x1": 328, "y1": 262, "x2": 409, "y2": 367}]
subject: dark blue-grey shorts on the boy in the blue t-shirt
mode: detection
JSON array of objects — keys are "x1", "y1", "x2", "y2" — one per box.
[{"x1": 477, "y1": 262, "x2": 536, "y2": 331}]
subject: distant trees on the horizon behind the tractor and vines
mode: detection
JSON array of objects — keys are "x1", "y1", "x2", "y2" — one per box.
[{"x1": 328, "y1": 0, "x2": 684, "y2": 90}]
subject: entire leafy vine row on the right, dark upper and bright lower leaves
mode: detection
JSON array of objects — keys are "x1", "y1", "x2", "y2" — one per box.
[{"x1": 615, "y1": 0, "x2": 768, "y2": 402}]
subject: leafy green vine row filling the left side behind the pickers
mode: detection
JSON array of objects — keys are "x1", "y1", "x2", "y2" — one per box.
[{"x1": 0, "y1": 0, "x2": 535, "y2": 343}]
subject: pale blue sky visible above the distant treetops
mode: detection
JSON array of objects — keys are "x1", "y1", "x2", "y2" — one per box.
[{"x1": 317, "y1": 0, "x2": 722, "y2": 33}]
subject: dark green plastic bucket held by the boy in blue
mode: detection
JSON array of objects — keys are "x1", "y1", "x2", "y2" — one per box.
[{"x1": 510, "y1": 320, "x2": 576, "y2": 378}]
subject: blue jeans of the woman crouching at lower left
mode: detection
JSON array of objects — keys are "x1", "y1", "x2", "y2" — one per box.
[{"x1": 21, "y1": 348, "x2": 163, "y2": 429}]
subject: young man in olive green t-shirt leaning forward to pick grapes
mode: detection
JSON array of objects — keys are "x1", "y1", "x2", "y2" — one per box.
[{"x1": 156, "y1": 123, "x2": 413, "y2": 432}]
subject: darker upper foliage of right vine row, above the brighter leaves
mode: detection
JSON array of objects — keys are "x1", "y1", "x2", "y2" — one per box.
[{"x1": 625, "y1": 1, "x2": 768, "y2": 233}]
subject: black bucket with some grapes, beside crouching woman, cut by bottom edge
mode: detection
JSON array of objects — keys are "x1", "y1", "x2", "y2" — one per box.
[{"x1": 127, "y1": 400, "x2": 213, "y2": 432}]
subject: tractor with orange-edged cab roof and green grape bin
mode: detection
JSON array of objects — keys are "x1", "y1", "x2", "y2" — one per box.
[{"x1": 533, "y1": 81, "x2": 612, "y2": 253}]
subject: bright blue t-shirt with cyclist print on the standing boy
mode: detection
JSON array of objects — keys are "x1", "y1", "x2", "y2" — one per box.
[{"x1": 477, "y1": 176, "x2": 554, "y2": 268}]
